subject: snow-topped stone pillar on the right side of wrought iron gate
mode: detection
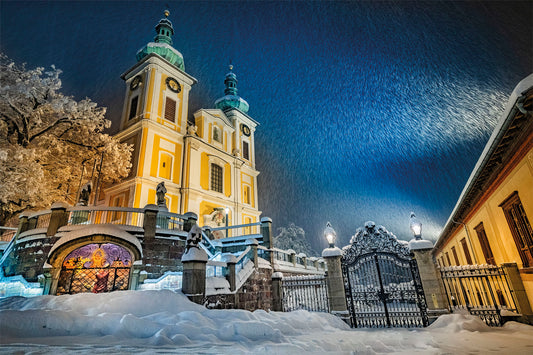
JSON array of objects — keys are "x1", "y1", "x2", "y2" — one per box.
[{"x1": 409, "y1": 239, "x2": 449, "y2": 324}]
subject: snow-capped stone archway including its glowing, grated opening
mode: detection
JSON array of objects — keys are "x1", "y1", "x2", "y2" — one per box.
[{"x1": 45, "y1": 226, "x2": 142, "y2": 295}]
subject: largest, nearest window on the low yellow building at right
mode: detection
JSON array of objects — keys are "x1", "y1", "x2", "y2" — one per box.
[{"x1": 500, "y1": 191, "x2": 533, "y2": 267}]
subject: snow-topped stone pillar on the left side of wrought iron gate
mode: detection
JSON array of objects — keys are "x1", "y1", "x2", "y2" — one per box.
[{"x1": 322, "y1": 247, "x2": 351, "y2": 325}]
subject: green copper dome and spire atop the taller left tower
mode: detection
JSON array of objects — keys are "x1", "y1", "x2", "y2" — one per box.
[{"x1": 137, "y1": 10, "x2": 185, "y2": 71}]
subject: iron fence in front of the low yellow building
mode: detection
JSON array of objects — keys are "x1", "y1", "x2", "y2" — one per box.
[{"x1": 441, "y1": 265, "x2": 517, "y2": 326}]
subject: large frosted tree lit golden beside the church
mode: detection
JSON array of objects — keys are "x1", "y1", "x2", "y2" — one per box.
[{"x1": 0, "y1": 54, "x2": 132, "y2": 225}]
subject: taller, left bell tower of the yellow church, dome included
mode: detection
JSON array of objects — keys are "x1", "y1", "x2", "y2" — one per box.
[{"x1": 105, "y1": 11, "x2": 196, "y2": 212}]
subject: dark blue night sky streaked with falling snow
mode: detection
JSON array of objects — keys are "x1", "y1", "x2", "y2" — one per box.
[{"x1": 0, "y1": 0, "x2": 533, "y2": 250}]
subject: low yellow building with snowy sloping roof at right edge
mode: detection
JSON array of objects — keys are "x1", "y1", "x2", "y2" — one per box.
[{"x1": 433, "y1": 74, "x2": 533, "y2": 308}]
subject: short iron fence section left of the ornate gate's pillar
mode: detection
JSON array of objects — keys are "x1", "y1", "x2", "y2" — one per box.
[{"x1": 281, "y1": 275, "x2": 329, "y2": 312}]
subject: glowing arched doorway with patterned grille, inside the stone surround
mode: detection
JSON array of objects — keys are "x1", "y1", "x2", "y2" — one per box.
[{"x1": 56, "y1": 243, "x2": 133, "y2": 295}]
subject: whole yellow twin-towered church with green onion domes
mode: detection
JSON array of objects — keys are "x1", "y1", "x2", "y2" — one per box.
[{"x1": 101, "y1": 11, "x2": 261, "y2": 236}]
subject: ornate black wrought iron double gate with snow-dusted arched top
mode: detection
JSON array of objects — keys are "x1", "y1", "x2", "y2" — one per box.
[{"x1": 342, "y1": 222, "x2": 428, "y2": 328}]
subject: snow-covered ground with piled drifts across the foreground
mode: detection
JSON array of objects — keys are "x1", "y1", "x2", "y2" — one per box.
[{"x1": 0, "y1": 290, "x2": 533, "y2": 355}]
